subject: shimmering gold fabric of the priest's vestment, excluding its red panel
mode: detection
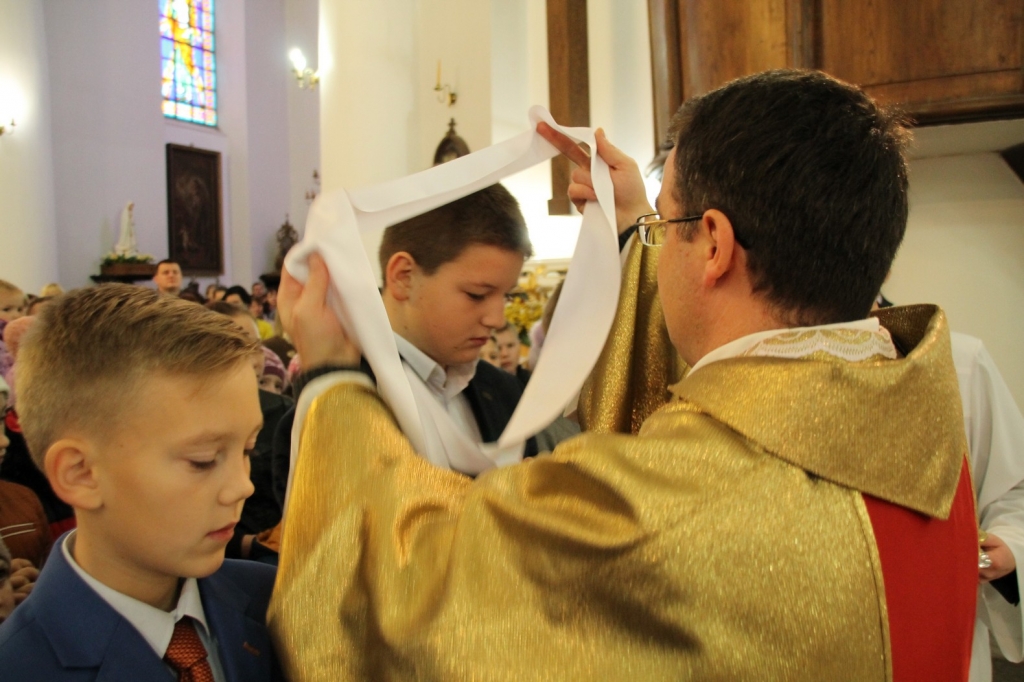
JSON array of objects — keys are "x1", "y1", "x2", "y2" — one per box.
[{"x1": 268, "y1": 241, "x2": 977, "y2": 682}]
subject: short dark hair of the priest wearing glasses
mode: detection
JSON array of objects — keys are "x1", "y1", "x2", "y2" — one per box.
[{"x1": 666, "y1": 71, "x2": 910, "y2": 326}]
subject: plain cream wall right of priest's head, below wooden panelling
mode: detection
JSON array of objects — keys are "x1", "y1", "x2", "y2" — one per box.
[{"x1": 883, "y1": 154, "x2": 1024, "y2": 408}]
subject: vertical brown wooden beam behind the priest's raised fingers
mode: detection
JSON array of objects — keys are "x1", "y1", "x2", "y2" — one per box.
[{"x1": 548, "y1": 0, "x2": 590, "y2": 215}]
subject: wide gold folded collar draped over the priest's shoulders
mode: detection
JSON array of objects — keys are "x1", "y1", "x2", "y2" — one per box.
[{"x1": 674, "y1": 305, "x2": 967, "y2": 519}]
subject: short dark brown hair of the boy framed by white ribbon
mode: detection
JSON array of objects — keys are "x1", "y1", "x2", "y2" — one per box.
[{"x1": 379, "y1": 184, "x2": 534, "y2": 274}]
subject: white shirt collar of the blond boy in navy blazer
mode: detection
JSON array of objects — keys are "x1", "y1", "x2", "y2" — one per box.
[{"x1": 60, "y1": 531, "x2": 210, "y2": 658}]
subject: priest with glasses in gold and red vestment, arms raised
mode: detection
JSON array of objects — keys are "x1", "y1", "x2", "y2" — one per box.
[{"x1": 269, "y1": 72, "x2": 979, "y2": 682}]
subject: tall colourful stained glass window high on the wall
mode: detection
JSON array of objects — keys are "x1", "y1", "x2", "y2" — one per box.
[{"x1": 159, "y1": 0, "x2": 217, "y2": 126}]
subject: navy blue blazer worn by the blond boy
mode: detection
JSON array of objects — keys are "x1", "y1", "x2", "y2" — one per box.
[{"x1": 0, "y1": 537, "x2": 284, "y2": 682}]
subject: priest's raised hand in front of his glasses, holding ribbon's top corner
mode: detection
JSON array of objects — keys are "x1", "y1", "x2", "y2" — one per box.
[{"x1": 537, "y1": 121, "x2": 654, "y2": 235}]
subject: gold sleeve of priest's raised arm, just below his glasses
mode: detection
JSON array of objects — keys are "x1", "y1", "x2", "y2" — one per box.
[{"x1": 577, "y1": 239, "x2": 686, "y2": 433}]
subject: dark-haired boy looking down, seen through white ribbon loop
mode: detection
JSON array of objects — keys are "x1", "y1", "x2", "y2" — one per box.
[{"x1": 379, "y1": 184, "x2": 537, "y2": 464}]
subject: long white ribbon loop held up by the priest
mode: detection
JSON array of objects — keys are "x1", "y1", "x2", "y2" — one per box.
[{"x1": 286, "y1": 106, "x2": 620, "y2": 474}]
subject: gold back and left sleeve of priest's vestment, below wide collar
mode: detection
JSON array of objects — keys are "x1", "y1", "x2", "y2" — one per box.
[{"x1": 268, "y1": 384, "x2": 888, "y2": 682}]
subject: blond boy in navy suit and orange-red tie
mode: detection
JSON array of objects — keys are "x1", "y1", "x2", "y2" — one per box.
[{"x1": 0, "y1": 285, "x2": 280, "y2": 682}]
